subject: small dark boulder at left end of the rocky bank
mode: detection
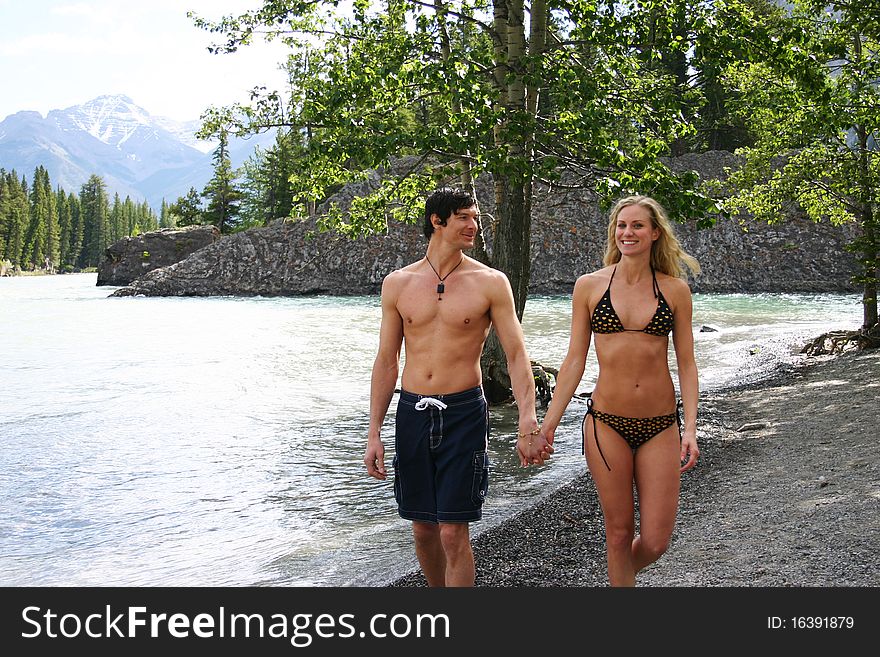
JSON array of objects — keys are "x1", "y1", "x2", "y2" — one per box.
[{"x1": 98, "y1": 226, "x2": 220, "y2": 285}]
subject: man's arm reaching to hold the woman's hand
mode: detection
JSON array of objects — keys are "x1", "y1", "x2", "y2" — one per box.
[{"x1": 489, "y1": 272, "x2": 553, "y2": 466}]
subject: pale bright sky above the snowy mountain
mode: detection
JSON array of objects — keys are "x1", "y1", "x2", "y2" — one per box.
[{"x1": 0, "y1": 0, "x2": 294, "y2": 121}]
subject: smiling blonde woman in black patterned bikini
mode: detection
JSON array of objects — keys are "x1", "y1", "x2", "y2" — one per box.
[{"x1": 541, "y1": 196, "x2": 700, "y2": 586}]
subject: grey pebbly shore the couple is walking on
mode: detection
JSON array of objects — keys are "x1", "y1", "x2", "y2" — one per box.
[{"x1": 385, "y1": 350, "x2": 880, "y2": 587}]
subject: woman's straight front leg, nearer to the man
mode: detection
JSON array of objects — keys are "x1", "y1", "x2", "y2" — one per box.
[{"x1": 584, "y1": 415, "x2": 636, "y2": 586}]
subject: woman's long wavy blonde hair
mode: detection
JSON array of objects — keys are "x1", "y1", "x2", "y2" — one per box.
[{"x1": 604, "y1": 195, "x2": 700, "y2": 278}]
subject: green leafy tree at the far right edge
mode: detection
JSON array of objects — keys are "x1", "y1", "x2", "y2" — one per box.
[{"x1": 727, "y1": 0, "x2": 880, "y2": 331}]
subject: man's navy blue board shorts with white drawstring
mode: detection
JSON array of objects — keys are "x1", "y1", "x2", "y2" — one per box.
[{"x1": 394, "y1": 386, "x2": 489, "y2": 523}]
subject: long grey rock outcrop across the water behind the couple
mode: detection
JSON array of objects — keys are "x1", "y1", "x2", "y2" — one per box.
[{"x1": 110, "y1": 151, "x2": 858, "y2": 296}]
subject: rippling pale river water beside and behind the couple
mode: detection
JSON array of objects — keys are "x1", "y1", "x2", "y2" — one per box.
[{"x1": 0, "y1": 274, "x2": 861, "y2": 586}]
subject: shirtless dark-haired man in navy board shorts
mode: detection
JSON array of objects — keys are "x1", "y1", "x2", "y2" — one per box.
[{"x1": 364, "y1": 188, "x2": 553, "y2": 586}]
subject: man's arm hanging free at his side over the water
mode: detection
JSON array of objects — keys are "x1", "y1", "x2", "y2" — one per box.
[{"x1": 364, "y1": 273, "x2": 403, "y2": 479}]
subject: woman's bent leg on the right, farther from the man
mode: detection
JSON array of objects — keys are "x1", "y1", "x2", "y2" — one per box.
[{"x1": 632, "y1": 424, "x2": 681, "y2": 573}]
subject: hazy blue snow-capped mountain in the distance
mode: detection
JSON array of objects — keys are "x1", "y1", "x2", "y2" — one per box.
[{"x1": 0, "y1": 95, "x2": 275, "y2": 210}]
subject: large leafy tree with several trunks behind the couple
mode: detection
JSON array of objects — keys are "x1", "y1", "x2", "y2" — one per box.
[{"x1": 196, "y1": 0, "x2": 728, "y2": 388}]
